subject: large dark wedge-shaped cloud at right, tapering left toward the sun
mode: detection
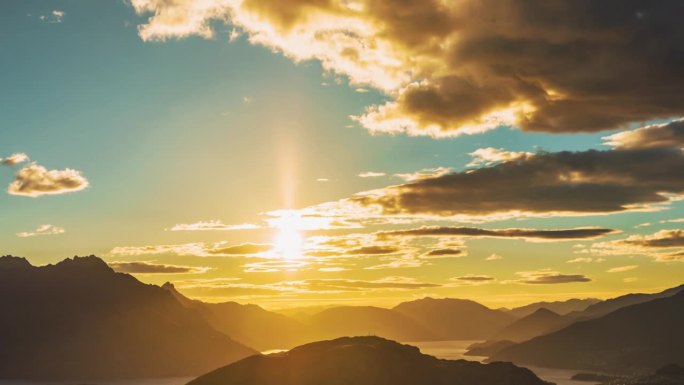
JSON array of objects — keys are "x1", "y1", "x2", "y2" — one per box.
[{"x1": 350, "y1": 149, "x2": 684, "y2": 216}]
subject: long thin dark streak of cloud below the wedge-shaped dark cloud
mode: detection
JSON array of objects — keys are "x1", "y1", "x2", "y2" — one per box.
[{"x1": 376, "y1": 226, "x2": 617, "y2": 241}]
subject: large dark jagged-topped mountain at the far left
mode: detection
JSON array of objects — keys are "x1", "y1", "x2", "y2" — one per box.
[{"x1": 0, "y1": 256, "x2": 255, "y2": 380}]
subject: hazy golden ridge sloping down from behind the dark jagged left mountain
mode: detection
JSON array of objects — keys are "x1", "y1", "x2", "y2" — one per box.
[{"x1": 162, "y1": 282, "x2": 314, "y2": 351}]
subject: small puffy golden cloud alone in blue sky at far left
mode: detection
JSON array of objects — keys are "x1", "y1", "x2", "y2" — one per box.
[{"x1": 7, "y1": 163, "x2": 89, "y2": 198}]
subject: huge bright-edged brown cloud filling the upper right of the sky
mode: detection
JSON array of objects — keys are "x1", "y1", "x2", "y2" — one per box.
[{"x1": 131, "y1": 0, "x2": 684, "y2": 136}]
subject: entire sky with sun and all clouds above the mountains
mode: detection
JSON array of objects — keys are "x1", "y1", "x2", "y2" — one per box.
[{"x1": 0, "y1": 0, "x2": 684, "y2": 309}]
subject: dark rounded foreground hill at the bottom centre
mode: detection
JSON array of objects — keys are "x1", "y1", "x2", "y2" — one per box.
[{"x1": 188, "y1": 337, "x2": 546, "y2": 385}]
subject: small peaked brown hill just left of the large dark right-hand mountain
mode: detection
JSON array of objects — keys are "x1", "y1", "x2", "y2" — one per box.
[{"x1": 490, "y1": 308, "x2": 572, "y2": 342}]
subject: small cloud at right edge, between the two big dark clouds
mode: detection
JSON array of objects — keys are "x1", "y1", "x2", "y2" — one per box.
[{"x1": 603, "y1": 120, "x2": 684, "y2": 150}]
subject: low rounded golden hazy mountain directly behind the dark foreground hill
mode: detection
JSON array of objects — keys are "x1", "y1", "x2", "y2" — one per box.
[{"x1": 308, "y1": 306, "x2": 437, "y2": 341}]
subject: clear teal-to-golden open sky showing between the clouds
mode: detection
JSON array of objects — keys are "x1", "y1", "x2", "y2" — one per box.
[{"x1": 0, "y1": 1, "x2": 684, "y2": 302}]
